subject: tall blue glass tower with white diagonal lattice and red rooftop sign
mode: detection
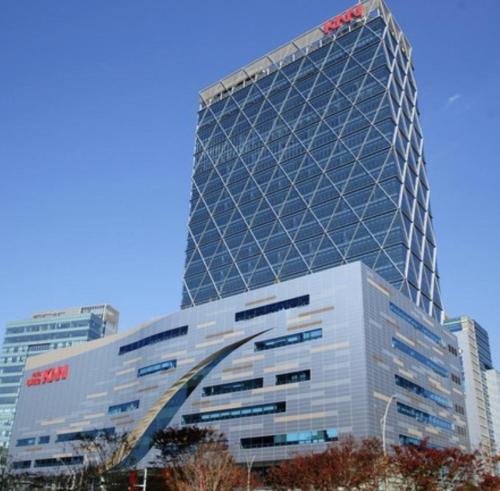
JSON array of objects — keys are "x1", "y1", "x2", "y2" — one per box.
[{"x1": 182, "y1": 0, "x2": 442, "y2": 318}]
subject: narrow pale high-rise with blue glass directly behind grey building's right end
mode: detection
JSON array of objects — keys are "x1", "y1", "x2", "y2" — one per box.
[{"x1": 444, "y1": 315, "x2": 494, "y2": 453}]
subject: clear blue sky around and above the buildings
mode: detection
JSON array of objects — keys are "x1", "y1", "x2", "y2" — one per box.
[{"x1": 0, "y1": 0, "x2": 500, "y2": 365}]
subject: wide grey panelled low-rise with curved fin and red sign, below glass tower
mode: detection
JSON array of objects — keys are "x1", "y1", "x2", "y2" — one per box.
[{"x1": 9, "y1": 262, "x2": 468, "y2": 473}]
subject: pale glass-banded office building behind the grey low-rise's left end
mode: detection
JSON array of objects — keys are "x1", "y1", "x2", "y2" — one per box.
[{"x1": 0, "y1": 304, "x2": 120, "y2": 448}]
